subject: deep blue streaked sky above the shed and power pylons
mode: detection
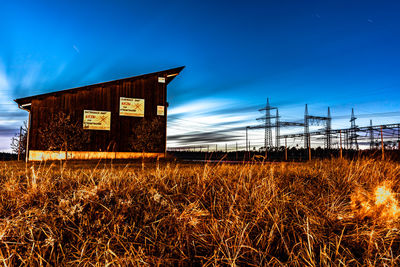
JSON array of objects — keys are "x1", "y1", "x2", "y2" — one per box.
[{"x1": 0, "y1": 0, "x2": 400, "y2": 151}]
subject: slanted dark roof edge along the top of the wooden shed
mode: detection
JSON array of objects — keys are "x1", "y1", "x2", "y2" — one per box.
[{"x1": 14, "y1": 66, "x2": 185, "y2": 105}]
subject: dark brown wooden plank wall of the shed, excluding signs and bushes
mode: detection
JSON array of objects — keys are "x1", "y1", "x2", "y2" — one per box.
[{"x1": 29, "y1": 75, "x2": 167, "y2": 152}]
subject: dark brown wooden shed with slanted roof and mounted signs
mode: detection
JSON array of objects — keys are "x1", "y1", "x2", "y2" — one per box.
[{"x1": 15, "y1": 67, "x2": 184, "y2": 161}]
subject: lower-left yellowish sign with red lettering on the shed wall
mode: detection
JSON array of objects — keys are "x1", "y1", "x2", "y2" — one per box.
[{"x1": 83, "y1": 110, "x2": 111, "y2": 131}]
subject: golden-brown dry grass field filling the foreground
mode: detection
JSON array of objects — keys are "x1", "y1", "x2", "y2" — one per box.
[{"x1": 0, "y1": 160, "x2": 400, "y2": 266}]
